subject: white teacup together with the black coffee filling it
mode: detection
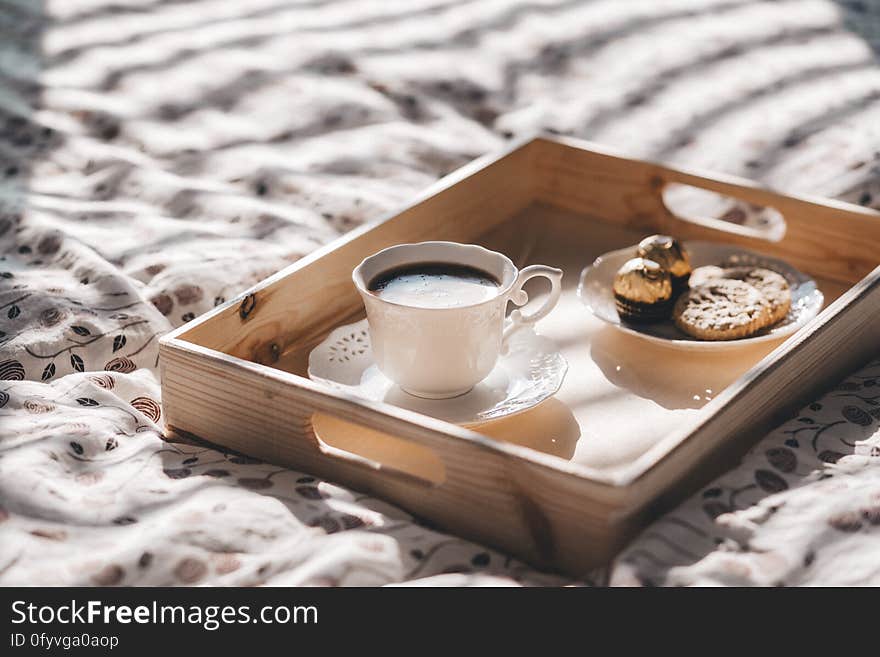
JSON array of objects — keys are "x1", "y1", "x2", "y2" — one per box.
[{"x1": 352, "y1": 242, "x2": 562, "y2": 399}]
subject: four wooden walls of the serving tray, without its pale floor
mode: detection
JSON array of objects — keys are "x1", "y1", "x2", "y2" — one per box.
[{"x1": 160, "y1": 138, "x2": 880, "y2": 575}]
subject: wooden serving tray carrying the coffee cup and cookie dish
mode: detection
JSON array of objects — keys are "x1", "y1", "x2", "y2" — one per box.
[{"x1": 160, "y1": 137, "x2": 880, "y2": 575}]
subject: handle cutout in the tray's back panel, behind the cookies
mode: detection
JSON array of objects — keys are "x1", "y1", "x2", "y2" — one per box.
[{"x1": 657, "y1": 176, "x2": 786, "y2": 242}]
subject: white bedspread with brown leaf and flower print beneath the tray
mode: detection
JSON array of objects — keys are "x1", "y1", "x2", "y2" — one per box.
[{"x1": 0, "y1": 0, "x2": 880, "y2": 585}]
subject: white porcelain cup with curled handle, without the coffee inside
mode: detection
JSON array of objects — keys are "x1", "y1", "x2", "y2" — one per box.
[{"x1": 352, "y1": 242, "x2": 562, "y2": 399}]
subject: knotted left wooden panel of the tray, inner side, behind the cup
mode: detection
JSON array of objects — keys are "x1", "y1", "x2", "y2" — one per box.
[{"x1": 174, "y1": 142, "x2": 533, "y2": 363}]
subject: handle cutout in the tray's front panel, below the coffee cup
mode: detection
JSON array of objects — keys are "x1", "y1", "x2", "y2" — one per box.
[{"x1": 312, "y1": 413, "x2": 446, "y2": 487}]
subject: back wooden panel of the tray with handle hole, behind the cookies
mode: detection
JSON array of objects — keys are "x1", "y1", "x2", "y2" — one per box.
[{"x1": 535, "y1": 139, "x2": 880, "y2": 284}]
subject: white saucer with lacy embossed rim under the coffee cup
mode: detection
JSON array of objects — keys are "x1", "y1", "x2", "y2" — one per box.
[{"x1": 309, "y1": 319, "x2": 568, "y2": 426}]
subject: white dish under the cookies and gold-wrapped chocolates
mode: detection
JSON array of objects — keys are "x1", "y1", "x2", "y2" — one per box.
[{"x1": 578, "y1": 242, "x2": 825, "y2": 351}]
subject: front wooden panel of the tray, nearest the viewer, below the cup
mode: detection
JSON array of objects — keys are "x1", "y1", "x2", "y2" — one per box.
[{"x1": 161, "y1": 341, "x2": 632, "y2": 575}]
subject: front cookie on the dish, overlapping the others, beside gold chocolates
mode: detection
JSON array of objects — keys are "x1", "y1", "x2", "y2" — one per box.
[{"x1": 672, "y1": 278, "x2": 771, "y2": 340}]
